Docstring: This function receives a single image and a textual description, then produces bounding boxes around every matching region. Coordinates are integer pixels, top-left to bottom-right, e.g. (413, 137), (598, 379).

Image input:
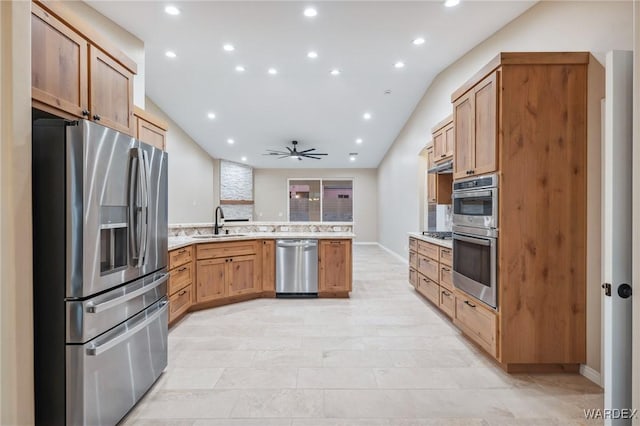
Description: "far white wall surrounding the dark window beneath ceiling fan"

(253, 169), (378, 242)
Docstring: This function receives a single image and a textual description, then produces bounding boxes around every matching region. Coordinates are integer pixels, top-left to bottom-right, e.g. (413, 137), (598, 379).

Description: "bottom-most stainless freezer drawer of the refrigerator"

(66, 297), (169, 426)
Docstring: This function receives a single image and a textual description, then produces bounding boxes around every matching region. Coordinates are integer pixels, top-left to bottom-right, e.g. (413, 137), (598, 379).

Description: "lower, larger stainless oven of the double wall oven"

(452, 225), (498, 308)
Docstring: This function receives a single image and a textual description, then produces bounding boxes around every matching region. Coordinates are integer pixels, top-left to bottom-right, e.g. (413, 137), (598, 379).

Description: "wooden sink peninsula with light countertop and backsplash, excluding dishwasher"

(167, 222), (355, 325)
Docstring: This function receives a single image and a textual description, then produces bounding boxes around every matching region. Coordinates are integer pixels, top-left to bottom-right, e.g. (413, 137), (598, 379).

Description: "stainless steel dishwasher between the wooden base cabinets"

(276, 240), (318, 297)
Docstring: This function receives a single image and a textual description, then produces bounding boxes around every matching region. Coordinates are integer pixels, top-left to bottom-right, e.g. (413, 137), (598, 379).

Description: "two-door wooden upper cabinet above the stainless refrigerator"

(31, 2), (136, 136)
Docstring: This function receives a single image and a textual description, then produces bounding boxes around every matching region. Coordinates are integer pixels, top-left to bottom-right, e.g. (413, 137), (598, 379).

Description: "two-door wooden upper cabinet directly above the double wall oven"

(453, 70), (500, 179)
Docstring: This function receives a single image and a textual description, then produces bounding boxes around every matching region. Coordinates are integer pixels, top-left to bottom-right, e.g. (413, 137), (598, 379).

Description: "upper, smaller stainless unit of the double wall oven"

(452, 174), (498, 229)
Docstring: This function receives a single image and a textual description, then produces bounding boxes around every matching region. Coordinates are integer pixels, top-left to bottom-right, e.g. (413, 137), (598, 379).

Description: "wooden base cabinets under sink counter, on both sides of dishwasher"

(167, 239), (352, 325)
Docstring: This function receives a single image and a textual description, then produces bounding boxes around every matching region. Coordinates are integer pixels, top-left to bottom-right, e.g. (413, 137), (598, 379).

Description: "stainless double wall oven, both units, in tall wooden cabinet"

(452, 174), (498, 308)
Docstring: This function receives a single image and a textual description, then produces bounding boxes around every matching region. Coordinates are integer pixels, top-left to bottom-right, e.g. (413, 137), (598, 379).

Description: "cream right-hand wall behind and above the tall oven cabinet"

(378, 2), (633, 380)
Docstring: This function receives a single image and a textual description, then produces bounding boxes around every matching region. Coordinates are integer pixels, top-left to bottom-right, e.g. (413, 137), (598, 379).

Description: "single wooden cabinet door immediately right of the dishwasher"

(319, 240), (351, 291)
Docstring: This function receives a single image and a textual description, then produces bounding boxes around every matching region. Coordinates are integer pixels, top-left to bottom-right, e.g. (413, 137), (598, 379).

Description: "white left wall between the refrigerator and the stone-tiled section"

(145, 98), (220, 223)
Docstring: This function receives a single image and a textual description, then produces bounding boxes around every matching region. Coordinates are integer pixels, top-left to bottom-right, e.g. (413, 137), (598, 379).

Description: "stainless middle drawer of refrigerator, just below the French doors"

(66, 270), (169, 343)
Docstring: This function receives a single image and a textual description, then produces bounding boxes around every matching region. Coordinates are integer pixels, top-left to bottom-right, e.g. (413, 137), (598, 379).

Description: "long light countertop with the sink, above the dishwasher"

(169, 232), (356, 250)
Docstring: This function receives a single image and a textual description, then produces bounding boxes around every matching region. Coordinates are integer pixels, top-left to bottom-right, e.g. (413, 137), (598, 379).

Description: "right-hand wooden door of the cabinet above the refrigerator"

(89, 46), (136, 137)
